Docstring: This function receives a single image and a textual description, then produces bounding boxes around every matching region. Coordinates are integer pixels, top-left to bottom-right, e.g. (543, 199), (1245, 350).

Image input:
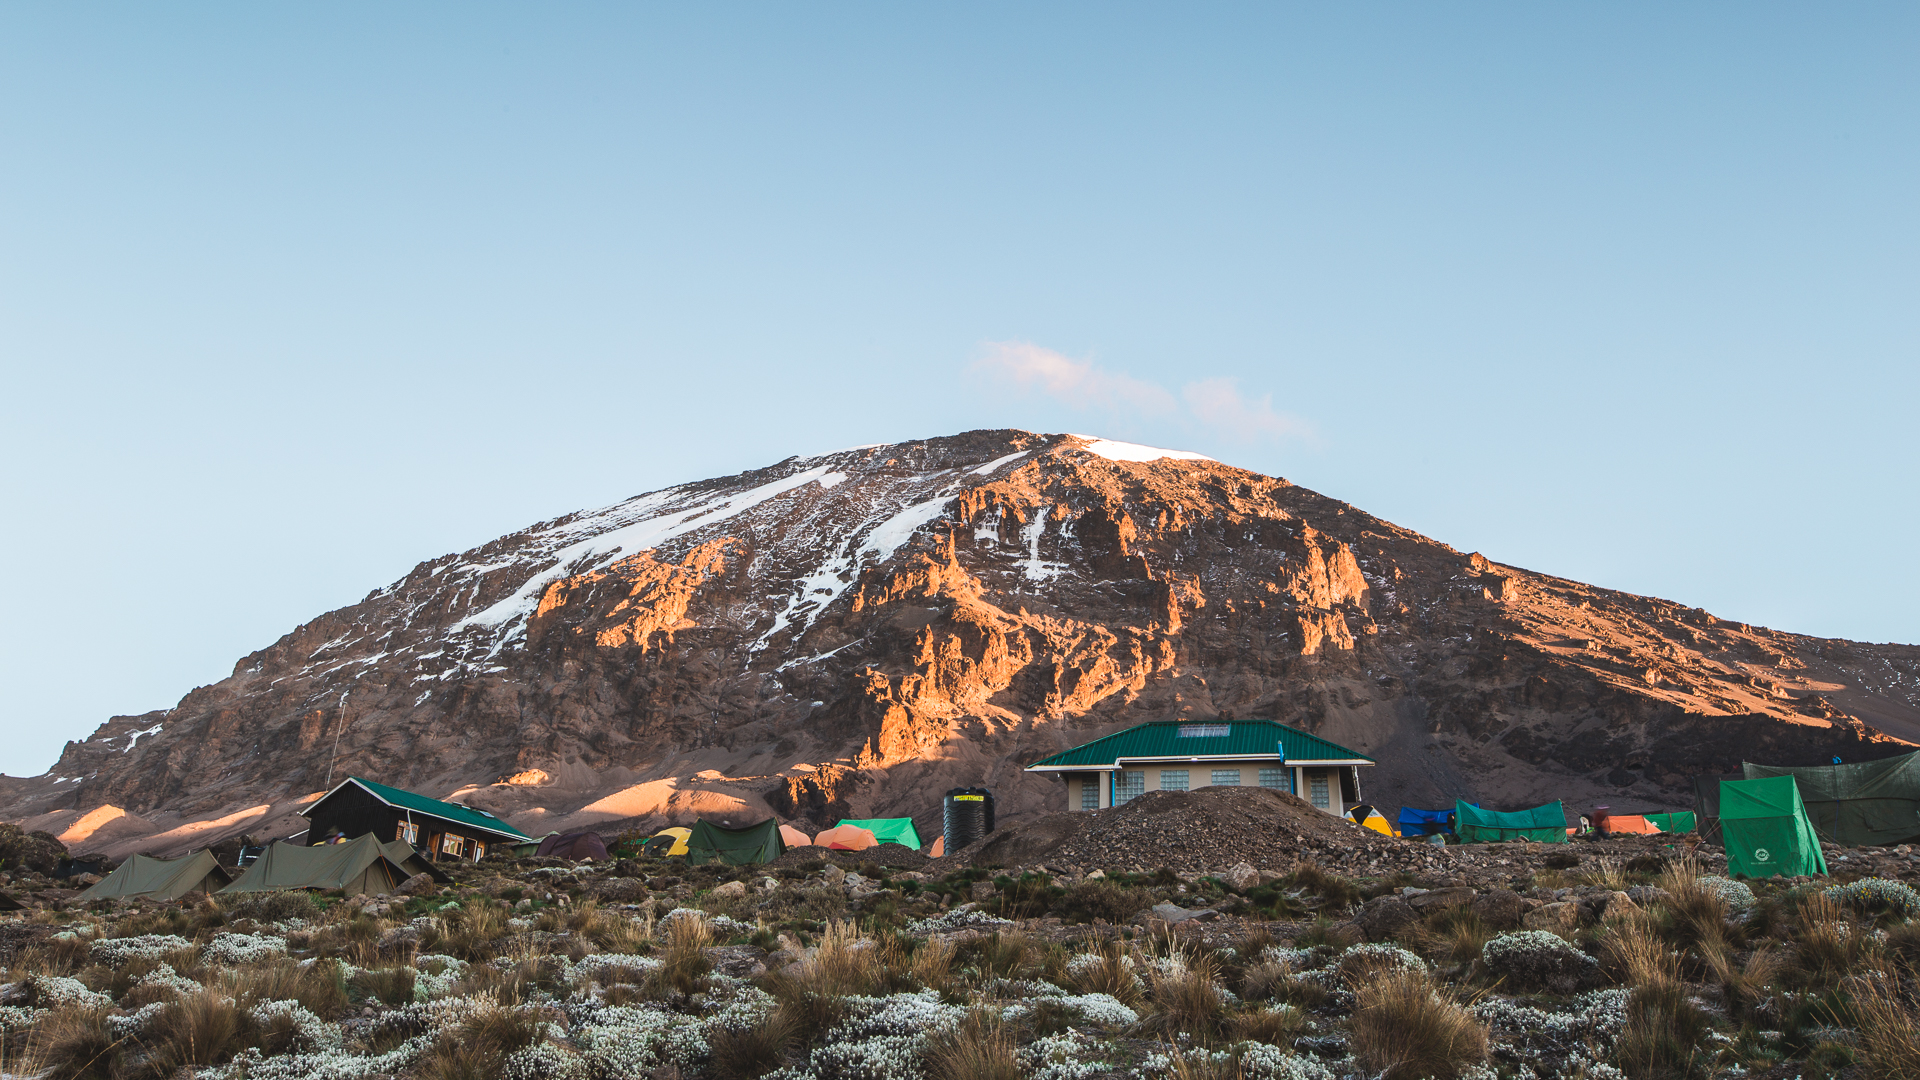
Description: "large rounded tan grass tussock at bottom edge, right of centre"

(1350, 969), (1488, 1080)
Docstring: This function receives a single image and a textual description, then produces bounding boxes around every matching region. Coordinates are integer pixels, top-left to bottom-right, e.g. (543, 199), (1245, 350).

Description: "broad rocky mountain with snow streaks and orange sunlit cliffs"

(0, 430), (1920, 851)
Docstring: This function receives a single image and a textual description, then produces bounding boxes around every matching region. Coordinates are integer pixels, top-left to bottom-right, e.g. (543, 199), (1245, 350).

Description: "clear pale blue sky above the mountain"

(0, 4), (1920, 774)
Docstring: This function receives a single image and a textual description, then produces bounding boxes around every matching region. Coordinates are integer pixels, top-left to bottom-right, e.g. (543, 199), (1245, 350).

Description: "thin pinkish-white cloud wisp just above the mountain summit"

(973, 342), (1313, 442)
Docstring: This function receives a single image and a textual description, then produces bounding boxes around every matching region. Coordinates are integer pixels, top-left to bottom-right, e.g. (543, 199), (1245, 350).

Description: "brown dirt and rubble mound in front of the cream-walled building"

(954, 788), (1428, 872)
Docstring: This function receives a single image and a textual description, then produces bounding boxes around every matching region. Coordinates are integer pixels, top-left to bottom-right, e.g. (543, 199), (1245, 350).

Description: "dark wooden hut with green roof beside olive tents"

(300, 776), (532, 861)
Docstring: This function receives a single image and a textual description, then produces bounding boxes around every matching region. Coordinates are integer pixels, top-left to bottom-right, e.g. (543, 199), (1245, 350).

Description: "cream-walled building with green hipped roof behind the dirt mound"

(1027, 721), (1373, 817)
